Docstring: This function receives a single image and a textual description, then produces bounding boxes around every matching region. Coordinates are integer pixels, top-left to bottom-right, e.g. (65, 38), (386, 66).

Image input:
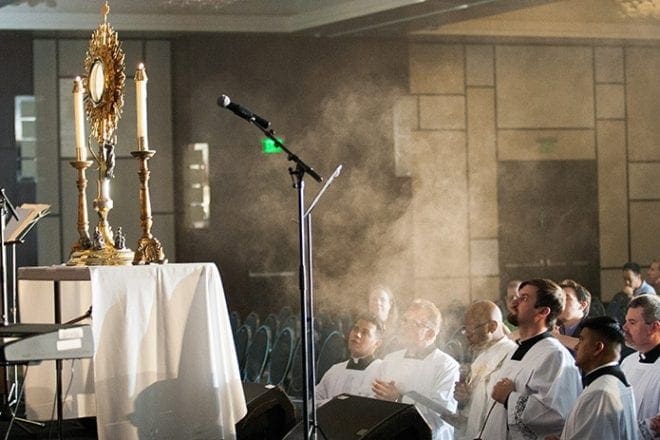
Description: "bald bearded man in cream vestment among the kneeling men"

(454, 301), (517, 440)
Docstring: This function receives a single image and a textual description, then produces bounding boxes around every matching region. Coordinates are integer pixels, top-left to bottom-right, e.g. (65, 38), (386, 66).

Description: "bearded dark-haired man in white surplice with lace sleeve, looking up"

(483, 279), (582, 440)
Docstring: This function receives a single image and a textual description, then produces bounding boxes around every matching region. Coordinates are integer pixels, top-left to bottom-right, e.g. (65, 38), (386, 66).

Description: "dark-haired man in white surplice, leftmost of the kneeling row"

(316, 315), (383, 405)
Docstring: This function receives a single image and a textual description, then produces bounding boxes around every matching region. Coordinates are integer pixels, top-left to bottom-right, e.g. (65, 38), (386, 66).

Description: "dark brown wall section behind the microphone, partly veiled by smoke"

(173, 36), (410, 314)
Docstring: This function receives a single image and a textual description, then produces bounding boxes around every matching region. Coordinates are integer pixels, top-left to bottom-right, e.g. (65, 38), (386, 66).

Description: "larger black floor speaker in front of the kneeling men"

(285, 394), (431, 440)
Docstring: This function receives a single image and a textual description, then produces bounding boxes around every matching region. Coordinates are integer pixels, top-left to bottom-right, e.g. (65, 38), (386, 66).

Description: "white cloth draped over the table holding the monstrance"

(19, 263), (247, 439)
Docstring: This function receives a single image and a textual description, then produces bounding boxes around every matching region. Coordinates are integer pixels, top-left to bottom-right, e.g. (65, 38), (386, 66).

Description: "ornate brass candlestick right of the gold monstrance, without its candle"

(131, 150), (167, 264)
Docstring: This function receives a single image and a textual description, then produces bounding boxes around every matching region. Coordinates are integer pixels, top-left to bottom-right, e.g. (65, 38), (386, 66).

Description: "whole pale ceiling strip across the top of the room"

(0, 0), (660, 39)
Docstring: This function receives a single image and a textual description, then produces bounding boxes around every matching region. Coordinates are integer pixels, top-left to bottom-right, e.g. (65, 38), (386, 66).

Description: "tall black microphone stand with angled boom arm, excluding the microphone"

(248, 121), (327, 439)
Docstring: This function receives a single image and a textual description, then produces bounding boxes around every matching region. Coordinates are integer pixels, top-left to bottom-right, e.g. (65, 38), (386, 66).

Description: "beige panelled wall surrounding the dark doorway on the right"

(395, 42), (660, 306)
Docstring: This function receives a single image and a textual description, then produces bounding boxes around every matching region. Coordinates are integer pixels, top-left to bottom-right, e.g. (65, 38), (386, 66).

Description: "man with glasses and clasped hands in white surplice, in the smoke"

(372, 299), (459, 440)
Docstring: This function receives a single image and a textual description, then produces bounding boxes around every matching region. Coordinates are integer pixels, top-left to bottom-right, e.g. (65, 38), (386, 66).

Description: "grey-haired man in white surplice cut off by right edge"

(621, 295), (660, 438)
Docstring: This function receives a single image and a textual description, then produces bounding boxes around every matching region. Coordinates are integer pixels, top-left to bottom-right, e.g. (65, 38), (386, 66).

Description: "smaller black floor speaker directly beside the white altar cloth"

(236, 383), (296, 440)
